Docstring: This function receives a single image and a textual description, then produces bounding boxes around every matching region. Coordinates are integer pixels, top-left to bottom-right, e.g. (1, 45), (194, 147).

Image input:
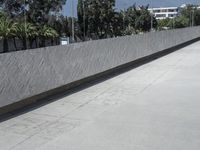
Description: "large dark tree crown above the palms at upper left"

(0, 0), (66, 30)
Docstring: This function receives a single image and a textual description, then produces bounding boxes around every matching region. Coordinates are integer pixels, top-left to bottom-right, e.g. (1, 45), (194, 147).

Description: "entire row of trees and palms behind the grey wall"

(0, 0), (200, 52)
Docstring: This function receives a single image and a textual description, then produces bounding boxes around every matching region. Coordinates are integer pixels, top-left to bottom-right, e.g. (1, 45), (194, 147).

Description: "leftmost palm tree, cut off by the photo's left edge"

(0, 17), (16, 52)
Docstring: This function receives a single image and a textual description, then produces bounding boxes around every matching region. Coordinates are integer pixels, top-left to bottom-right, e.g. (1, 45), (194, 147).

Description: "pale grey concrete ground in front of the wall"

(0, 42), (200, 150)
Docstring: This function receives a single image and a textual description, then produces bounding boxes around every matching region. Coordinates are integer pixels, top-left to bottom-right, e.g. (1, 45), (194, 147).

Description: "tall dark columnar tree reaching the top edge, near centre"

(82, 0), (115, 38)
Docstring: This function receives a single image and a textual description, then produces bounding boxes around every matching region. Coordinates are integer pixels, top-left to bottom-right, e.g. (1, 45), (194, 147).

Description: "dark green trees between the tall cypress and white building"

(77, 0), (157, 39)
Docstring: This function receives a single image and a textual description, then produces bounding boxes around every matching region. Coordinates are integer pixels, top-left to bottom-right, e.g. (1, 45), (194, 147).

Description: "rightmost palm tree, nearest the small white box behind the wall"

(39, 25), (59, 47)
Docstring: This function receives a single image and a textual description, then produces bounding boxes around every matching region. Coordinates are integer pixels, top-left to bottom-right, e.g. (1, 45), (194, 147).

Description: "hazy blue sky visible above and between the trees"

(63, 0), (200, 16)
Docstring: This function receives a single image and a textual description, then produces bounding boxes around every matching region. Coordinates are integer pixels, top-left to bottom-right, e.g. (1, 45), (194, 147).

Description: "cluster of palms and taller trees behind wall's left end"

(0, 0), (68, 52)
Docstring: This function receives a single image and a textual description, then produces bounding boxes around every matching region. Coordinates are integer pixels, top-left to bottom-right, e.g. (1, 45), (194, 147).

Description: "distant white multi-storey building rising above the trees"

(149, 7), (179, 20)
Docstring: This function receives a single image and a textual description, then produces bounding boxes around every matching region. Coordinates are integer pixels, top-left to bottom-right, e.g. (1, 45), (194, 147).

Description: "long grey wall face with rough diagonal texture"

(0, 27), (200, 107)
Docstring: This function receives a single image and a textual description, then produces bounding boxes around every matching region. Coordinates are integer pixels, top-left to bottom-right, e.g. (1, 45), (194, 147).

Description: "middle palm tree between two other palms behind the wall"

(16, 23), (38, 50)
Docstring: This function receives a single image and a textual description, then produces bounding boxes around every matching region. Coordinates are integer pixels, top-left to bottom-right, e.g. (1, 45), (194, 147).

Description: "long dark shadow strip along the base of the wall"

(0, 38), (200, 123)
